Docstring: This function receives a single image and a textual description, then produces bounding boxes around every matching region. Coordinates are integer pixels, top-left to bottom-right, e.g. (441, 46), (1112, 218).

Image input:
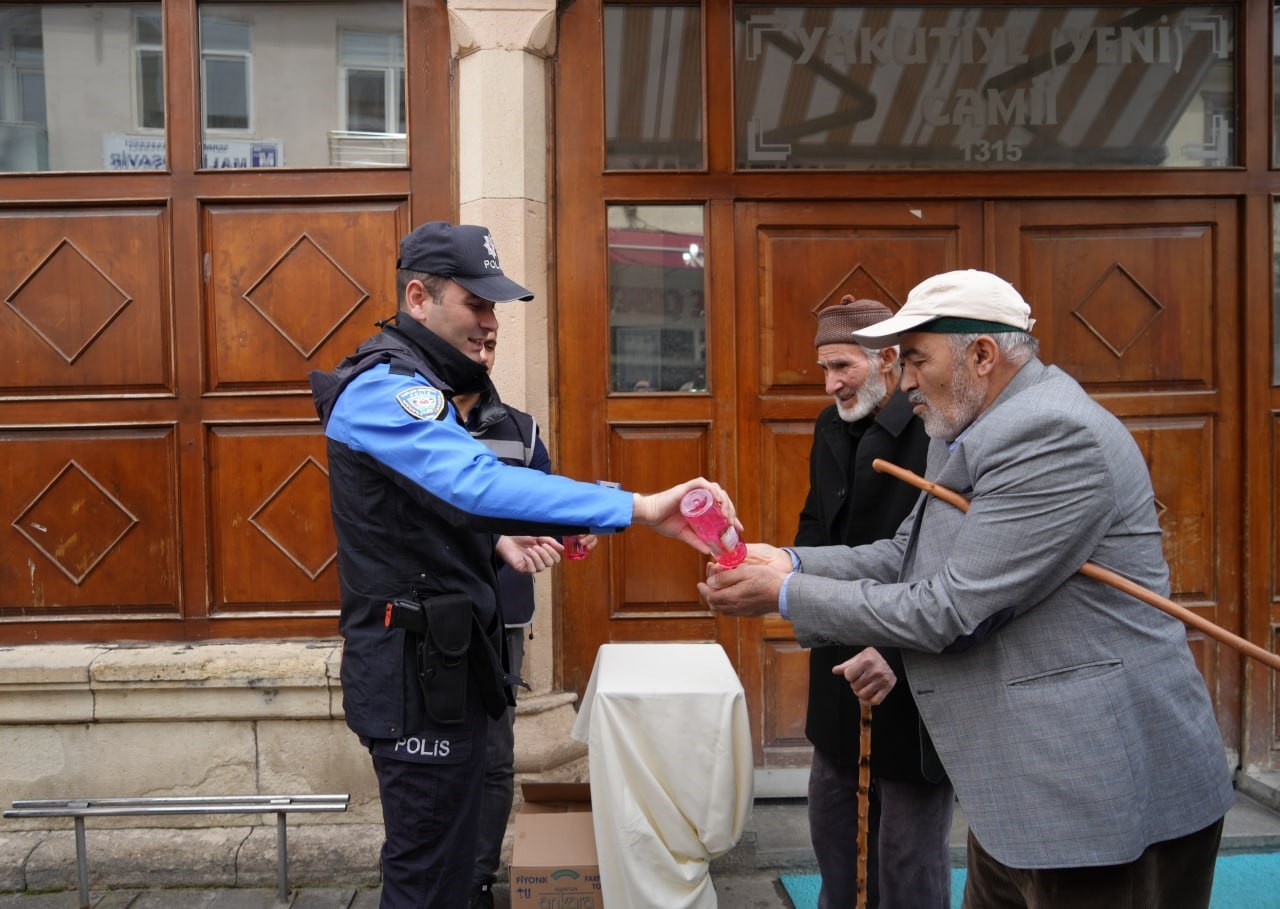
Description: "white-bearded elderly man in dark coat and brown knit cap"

(795, 297), (955, 909)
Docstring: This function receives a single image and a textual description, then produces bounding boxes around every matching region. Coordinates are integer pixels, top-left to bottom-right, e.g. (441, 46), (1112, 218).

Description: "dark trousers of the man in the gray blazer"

(964, 819), (1222, 909)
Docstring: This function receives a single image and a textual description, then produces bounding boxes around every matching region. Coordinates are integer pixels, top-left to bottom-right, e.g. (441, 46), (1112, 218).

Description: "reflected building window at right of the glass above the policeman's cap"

(338, 29), (404, 134)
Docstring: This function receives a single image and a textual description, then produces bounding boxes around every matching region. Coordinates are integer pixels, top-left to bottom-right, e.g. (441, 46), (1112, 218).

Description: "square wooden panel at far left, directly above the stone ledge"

(0, 426), (182, 621)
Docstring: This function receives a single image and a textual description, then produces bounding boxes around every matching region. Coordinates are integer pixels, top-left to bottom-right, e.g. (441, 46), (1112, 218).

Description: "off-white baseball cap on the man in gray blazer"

(852, 269), (1036, 347)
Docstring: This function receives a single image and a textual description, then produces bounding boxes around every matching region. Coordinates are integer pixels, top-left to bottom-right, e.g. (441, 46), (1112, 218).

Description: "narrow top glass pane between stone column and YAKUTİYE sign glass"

(604, 4), (703, 170)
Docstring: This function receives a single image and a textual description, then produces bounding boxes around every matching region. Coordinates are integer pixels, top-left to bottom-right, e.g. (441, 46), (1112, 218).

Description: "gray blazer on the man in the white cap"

(786, 360), (1234, 868)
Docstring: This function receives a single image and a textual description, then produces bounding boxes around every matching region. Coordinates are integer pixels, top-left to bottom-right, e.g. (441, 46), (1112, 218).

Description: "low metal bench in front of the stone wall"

(4, 794), (351, 909)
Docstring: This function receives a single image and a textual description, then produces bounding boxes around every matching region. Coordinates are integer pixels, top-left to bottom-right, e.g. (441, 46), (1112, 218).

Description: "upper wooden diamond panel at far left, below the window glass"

(0, 206), (173, 397)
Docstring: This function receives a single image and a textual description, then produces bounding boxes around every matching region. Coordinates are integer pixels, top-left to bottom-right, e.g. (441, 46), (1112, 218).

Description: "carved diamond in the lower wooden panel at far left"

(13, 461), (138, 586)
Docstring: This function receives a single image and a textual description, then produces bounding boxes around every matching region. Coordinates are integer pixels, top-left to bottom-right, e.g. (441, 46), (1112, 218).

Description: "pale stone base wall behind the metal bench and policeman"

(0, 640), (586, 891)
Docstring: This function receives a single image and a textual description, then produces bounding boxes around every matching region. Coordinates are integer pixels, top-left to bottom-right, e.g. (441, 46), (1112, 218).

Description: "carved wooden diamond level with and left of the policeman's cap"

(244, 233), (369, 358)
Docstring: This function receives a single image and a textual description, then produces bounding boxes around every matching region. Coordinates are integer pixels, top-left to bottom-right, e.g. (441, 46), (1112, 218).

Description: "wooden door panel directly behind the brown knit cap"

(756, 217), (959, 393)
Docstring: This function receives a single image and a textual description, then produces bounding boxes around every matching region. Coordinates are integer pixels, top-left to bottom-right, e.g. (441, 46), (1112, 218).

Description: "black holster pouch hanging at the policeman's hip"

(417, 594), (472, 723)
